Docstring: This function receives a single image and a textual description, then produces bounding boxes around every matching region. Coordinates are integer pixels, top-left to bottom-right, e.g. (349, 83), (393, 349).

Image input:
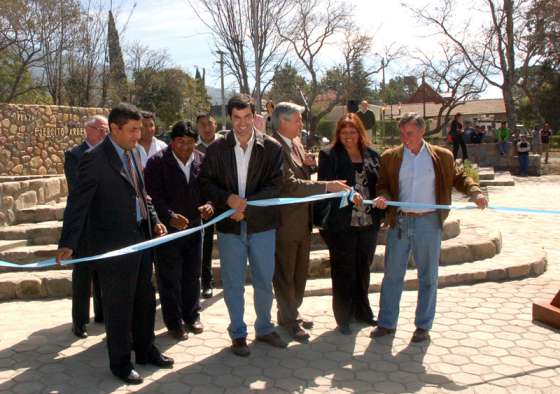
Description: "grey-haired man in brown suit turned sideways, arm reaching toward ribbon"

(272, 103), (350, 342)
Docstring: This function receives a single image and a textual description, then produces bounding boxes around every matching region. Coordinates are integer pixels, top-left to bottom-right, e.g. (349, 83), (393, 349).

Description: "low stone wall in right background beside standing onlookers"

(468, 142), (541, 176)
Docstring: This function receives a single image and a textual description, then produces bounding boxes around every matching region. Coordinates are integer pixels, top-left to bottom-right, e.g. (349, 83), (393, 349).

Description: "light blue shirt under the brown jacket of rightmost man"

(399, 143), (436, 212)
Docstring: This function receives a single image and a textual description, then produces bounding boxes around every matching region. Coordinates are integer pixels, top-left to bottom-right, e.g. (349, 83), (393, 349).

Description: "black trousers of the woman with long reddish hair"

(321, 227), (377, 326)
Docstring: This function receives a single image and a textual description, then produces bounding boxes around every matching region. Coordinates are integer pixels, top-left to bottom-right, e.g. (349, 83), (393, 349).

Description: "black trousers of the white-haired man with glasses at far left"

(72, 263), (103, 326)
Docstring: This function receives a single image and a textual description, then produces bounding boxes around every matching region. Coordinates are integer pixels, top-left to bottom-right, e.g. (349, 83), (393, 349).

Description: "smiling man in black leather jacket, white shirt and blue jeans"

(199, 95), (287, 357)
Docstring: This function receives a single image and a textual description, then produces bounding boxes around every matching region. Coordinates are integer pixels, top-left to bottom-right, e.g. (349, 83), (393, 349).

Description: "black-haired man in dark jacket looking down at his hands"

(144, 121), (213, 341)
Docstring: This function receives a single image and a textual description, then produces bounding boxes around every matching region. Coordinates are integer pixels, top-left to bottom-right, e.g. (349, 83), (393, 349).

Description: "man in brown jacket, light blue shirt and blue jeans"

(371, 113), (488, 342)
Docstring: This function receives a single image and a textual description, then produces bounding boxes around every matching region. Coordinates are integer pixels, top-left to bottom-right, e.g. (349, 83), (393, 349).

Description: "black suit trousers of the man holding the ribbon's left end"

(95, 243), (158, 376)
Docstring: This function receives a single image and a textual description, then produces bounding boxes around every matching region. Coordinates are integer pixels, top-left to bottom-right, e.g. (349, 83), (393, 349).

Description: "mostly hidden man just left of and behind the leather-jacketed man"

(196, 113), (223, 298)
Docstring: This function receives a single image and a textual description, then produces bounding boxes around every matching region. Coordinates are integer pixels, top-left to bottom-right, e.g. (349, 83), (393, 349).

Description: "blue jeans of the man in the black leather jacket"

(218, 222), (276, 339)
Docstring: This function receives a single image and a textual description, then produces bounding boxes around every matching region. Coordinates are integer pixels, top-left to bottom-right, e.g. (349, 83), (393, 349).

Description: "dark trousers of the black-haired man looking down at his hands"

(156, 233), (202, 330)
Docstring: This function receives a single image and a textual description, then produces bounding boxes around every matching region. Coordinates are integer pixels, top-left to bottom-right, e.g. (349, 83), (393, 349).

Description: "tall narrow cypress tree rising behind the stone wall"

(107, 11), (128, 104)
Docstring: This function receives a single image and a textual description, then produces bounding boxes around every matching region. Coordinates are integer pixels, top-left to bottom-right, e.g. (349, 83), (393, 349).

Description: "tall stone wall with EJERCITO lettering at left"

(0, 104), (109, 175)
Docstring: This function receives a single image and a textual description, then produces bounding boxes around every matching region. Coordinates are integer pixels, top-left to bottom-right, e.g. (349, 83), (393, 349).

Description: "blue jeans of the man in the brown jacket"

(378, 213), (441, 330)
